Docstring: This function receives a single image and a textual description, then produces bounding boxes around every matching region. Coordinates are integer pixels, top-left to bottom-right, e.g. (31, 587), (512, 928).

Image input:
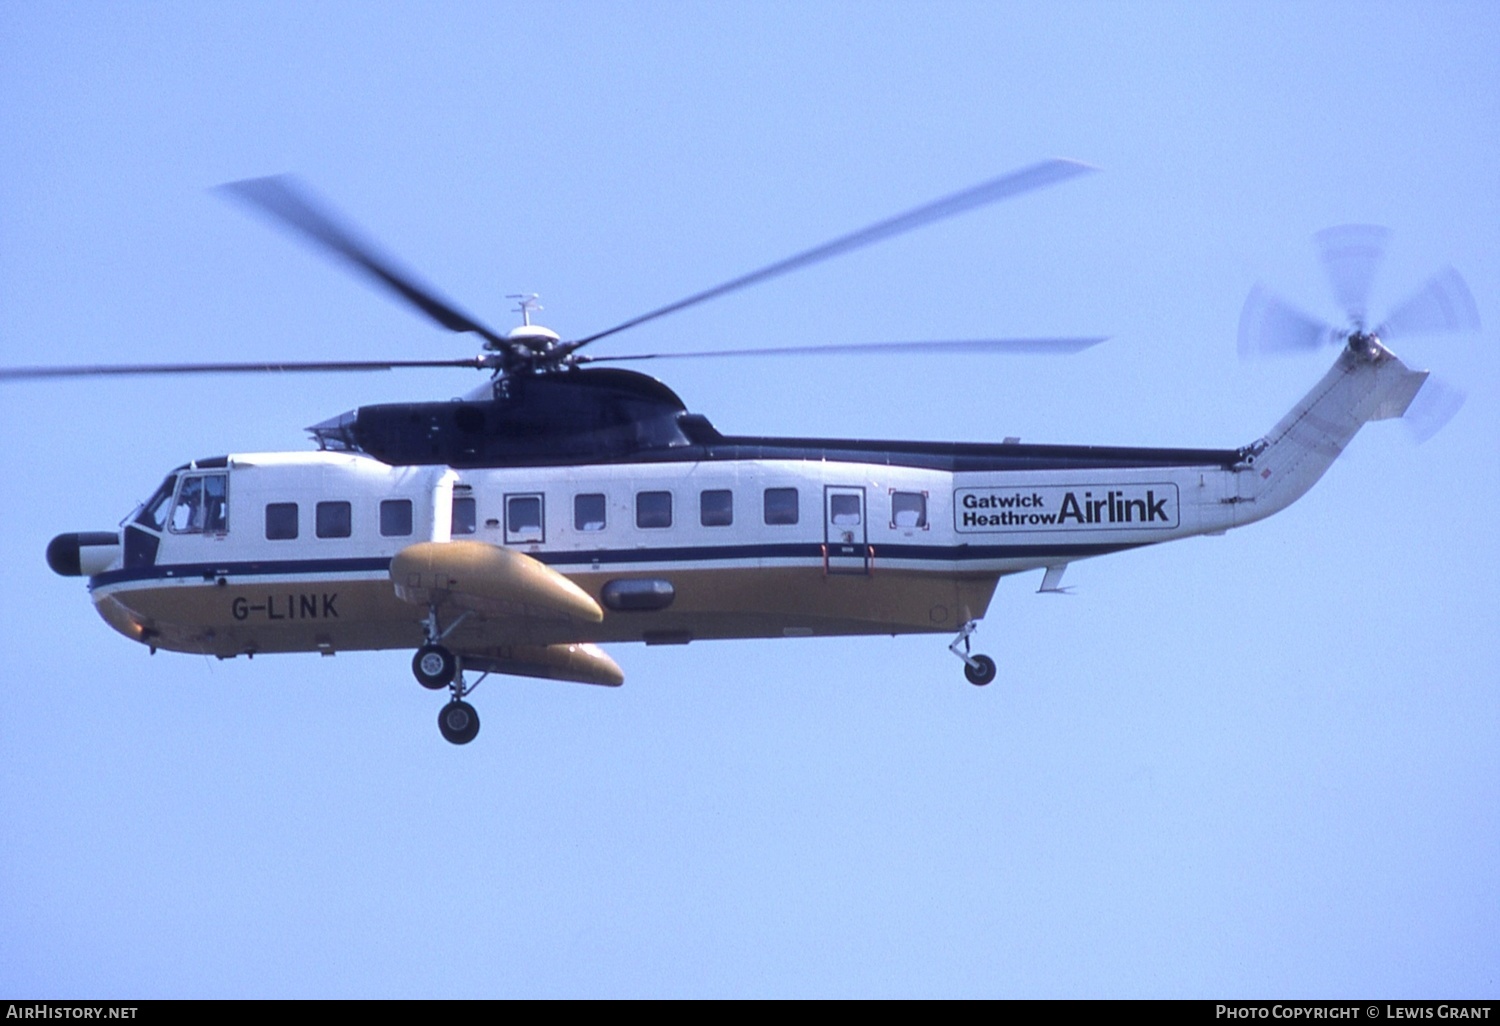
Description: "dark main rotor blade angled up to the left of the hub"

(218, 174), (504, 345)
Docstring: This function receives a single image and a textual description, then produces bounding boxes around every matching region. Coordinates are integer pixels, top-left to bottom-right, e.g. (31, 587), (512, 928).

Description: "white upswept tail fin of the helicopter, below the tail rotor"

(1235, 336), (1427, 525)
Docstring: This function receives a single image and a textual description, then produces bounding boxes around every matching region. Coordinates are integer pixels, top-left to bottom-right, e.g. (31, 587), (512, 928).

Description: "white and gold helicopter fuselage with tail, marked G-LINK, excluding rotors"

(64, 344), (1425, 702)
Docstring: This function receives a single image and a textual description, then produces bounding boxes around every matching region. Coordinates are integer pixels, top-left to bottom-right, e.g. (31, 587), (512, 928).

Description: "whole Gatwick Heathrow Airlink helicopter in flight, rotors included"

(0, 161), (1478, 744)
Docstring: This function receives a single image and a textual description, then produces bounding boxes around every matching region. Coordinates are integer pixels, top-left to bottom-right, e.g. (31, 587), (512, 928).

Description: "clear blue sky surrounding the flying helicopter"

(0, 3), (1500, 998)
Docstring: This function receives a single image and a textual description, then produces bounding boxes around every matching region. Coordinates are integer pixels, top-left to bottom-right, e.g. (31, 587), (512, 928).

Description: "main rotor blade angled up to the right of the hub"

(567, 161), (1095, 351)
